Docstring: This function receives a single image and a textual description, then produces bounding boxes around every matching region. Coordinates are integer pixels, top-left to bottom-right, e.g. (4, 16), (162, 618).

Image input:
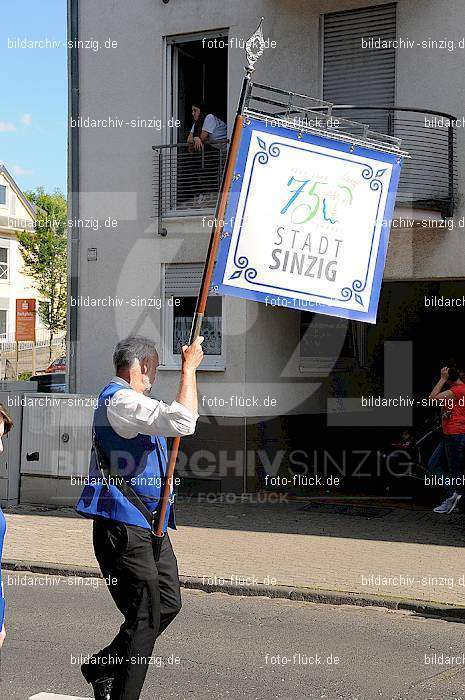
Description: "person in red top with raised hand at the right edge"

(428, 367), (465, 513)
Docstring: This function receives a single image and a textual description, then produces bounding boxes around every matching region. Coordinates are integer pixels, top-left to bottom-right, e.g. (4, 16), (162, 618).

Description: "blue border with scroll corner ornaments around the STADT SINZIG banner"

(213, 119), (401, 323)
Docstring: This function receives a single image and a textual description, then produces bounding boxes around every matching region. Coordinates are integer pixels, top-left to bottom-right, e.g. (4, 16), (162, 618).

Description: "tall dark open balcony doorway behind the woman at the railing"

(163, 30), (228, 212)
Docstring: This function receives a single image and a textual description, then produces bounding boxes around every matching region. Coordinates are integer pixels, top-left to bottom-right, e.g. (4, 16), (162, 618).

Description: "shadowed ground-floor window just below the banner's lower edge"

(300, 311), (367, 377)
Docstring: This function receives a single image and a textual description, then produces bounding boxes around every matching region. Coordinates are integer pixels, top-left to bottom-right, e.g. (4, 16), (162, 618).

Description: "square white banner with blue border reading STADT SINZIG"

(213, 118), (401, 323)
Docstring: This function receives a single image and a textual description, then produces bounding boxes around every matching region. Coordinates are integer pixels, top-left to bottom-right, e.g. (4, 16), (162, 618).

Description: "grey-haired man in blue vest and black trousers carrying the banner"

(76, 336), (203, 700)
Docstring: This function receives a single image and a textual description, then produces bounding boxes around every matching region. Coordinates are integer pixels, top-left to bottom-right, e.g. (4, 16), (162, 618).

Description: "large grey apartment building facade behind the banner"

(69, 0), (465, 493)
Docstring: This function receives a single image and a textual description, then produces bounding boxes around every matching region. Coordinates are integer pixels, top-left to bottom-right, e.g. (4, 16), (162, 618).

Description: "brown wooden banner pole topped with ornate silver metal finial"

(154, 17), (265, 540)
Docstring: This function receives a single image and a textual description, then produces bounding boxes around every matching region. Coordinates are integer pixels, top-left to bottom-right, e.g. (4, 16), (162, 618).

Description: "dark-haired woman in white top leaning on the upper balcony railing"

(187, 100), (227, 206)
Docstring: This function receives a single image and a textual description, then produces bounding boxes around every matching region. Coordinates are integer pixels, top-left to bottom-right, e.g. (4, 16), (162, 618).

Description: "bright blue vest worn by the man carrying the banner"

(76, 382), (176, 531)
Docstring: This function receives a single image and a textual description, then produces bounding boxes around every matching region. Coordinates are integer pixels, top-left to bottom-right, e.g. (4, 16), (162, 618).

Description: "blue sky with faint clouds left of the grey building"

(0, 0), (68, 193)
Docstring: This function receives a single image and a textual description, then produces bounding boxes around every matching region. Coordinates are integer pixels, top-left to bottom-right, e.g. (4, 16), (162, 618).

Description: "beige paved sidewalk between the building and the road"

(3, 499), (465, 615)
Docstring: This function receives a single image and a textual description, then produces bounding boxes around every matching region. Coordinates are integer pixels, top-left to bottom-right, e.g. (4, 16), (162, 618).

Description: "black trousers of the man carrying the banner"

(82, 519), (181, 700)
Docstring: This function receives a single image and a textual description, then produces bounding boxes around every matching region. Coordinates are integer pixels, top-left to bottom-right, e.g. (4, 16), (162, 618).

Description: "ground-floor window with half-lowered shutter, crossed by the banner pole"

(163, 263), (225, 369)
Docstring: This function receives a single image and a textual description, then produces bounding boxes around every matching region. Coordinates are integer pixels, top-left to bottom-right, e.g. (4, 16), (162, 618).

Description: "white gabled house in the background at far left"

(0, 164), (44, 340)
